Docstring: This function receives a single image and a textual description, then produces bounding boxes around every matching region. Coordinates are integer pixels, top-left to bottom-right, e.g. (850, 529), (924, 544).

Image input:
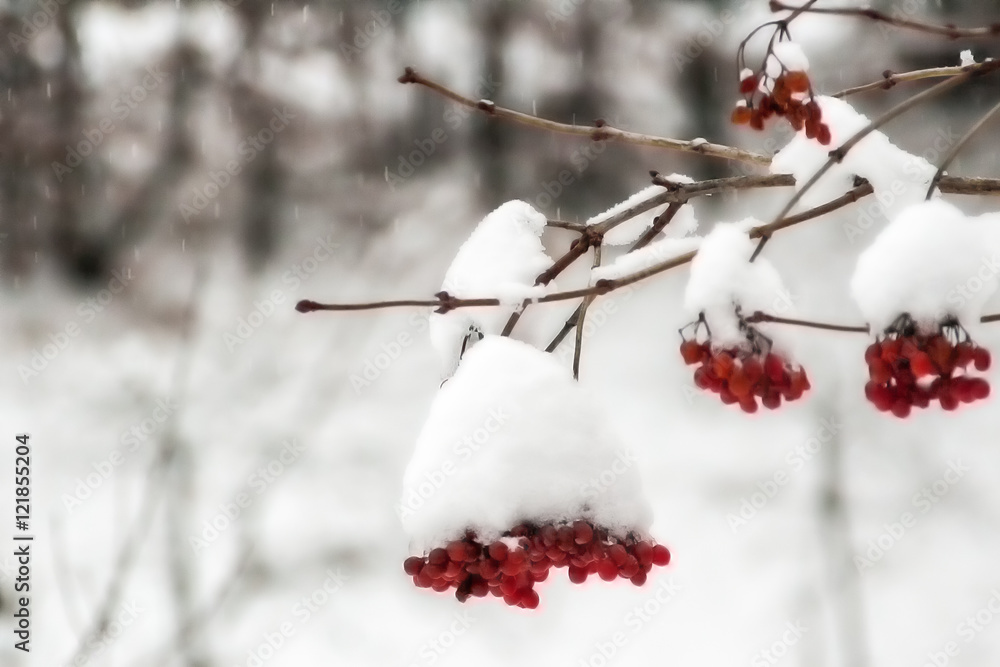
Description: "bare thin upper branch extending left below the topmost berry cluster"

(398, 67), (770, 165)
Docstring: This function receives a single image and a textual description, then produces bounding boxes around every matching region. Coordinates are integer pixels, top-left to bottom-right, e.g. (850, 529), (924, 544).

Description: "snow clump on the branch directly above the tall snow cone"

(430, 200), (555, 374)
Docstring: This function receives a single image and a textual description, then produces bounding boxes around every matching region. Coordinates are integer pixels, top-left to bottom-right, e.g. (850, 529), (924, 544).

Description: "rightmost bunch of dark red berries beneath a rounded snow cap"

(865, 315), (992, 418)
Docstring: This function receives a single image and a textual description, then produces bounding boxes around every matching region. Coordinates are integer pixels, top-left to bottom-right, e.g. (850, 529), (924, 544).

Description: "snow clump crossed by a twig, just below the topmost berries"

(771, 96), (937, 218)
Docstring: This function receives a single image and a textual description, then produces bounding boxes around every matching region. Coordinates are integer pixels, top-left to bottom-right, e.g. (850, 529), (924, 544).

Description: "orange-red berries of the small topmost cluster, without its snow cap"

(732, 70), (831, 146)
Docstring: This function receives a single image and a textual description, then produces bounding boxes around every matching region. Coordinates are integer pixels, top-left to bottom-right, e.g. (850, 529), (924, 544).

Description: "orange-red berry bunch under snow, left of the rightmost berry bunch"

(681, 340), (810, 413)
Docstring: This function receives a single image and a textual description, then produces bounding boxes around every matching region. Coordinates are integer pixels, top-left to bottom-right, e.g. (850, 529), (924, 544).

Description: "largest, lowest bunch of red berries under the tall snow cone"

(403, 521), (670, 609)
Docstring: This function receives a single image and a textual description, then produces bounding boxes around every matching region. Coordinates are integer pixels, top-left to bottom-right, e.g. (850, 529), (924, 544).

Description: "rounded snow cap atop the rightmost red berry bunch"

(851, 199), (1000, 333)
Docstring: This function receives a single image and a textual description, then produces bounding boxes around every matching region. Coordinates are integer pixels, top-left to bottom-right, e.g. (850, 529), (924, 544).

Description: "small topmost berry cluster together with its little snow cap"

(732, 42), (832, 146)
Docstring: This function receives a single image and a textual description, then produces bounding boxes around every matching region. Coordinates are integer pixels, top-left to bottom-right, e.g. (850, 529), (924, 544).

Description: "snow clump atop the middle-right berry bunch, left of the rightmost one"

(684, 219), (788, 349)
